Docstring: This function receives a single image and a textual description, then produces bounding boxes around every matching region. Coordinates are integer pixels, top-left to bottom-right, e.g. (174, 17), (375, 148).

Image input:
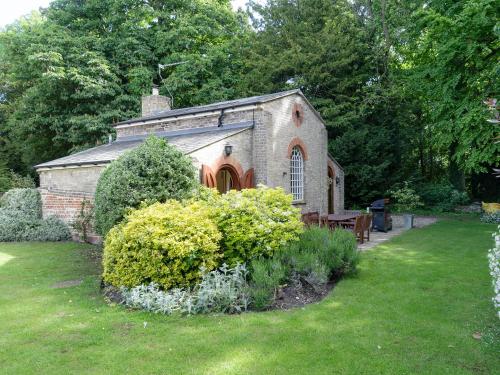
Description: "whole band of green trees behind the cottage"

(0, 0), (500, 205)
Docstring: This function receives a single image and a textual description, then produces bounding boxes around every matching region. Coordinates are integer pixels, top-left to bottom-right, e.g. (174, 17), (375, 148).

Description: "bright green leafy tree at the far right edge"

(403, 0), (500, 189)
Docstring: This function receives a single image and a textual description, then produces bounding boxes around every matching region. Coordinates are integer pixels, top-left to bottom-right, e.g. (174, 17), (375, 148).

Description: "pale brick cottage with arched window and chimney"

(35, 88), (344, 238)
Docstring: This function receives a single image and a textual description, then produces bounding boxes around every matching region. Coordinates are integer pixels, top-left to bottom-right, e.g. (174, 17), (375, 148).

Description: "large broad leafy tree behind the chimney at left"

(0, 0), (250, 167)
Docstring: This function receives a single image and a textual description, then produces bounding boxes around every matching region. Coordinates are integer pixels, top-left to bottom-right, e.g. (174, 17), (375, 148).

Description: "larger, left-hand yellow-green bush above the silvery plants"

(103, 200), (221, 289)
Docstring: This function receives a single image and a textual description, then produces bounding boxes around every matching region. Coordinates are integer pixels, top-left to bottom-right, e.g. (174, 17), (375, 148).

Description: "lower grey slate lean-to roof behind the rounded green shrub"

(35, 122), (253, 169)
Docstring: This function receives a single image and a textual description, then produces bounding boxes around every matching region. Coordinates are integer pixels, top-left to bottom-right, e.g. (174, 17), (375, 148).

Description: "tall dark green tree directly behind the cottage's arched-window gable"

(246, 0), (416, 204)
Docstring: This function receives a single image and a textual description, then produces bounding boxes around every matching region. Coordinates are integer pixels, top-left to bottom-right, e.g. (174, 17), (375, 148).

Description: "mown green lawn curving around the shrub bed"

(0, 219), (500, 375)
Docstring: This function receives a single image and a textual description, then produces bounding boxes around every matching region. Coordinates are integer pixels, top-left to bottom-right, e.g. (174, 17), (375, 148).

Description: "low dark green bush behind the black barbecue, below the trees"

(418, 182), (469, 212)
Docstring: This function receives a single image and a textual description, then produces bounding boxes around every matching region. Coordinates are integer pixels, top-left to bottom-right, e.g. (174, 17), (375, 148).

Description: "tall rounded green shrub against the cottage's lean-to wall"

(94, 136), (197, 236)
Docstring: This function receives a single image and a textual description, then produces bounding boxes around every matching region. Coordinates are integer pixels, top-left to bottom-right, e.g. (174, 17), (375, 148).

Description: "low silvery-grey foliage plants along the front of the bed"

(121, 264), (249, 314)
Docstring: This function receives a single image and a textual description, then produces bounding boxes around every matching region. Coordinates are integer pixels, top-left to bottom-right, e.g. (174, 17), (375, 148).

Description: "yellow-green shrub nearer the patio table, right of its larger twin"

(205, 186), (303, 266)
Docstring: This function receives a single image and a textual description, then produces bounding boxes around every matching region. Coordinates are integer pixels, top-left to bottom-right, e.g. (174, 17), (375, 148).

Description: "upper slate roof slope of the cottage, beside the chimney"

(114, 89), (303, 126)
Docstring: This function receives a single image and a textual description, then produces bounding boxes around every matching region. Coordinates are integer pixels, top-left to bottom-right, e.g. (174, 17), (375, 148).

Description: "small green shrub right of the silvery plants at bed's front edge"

(250, 256), (289, 310)
